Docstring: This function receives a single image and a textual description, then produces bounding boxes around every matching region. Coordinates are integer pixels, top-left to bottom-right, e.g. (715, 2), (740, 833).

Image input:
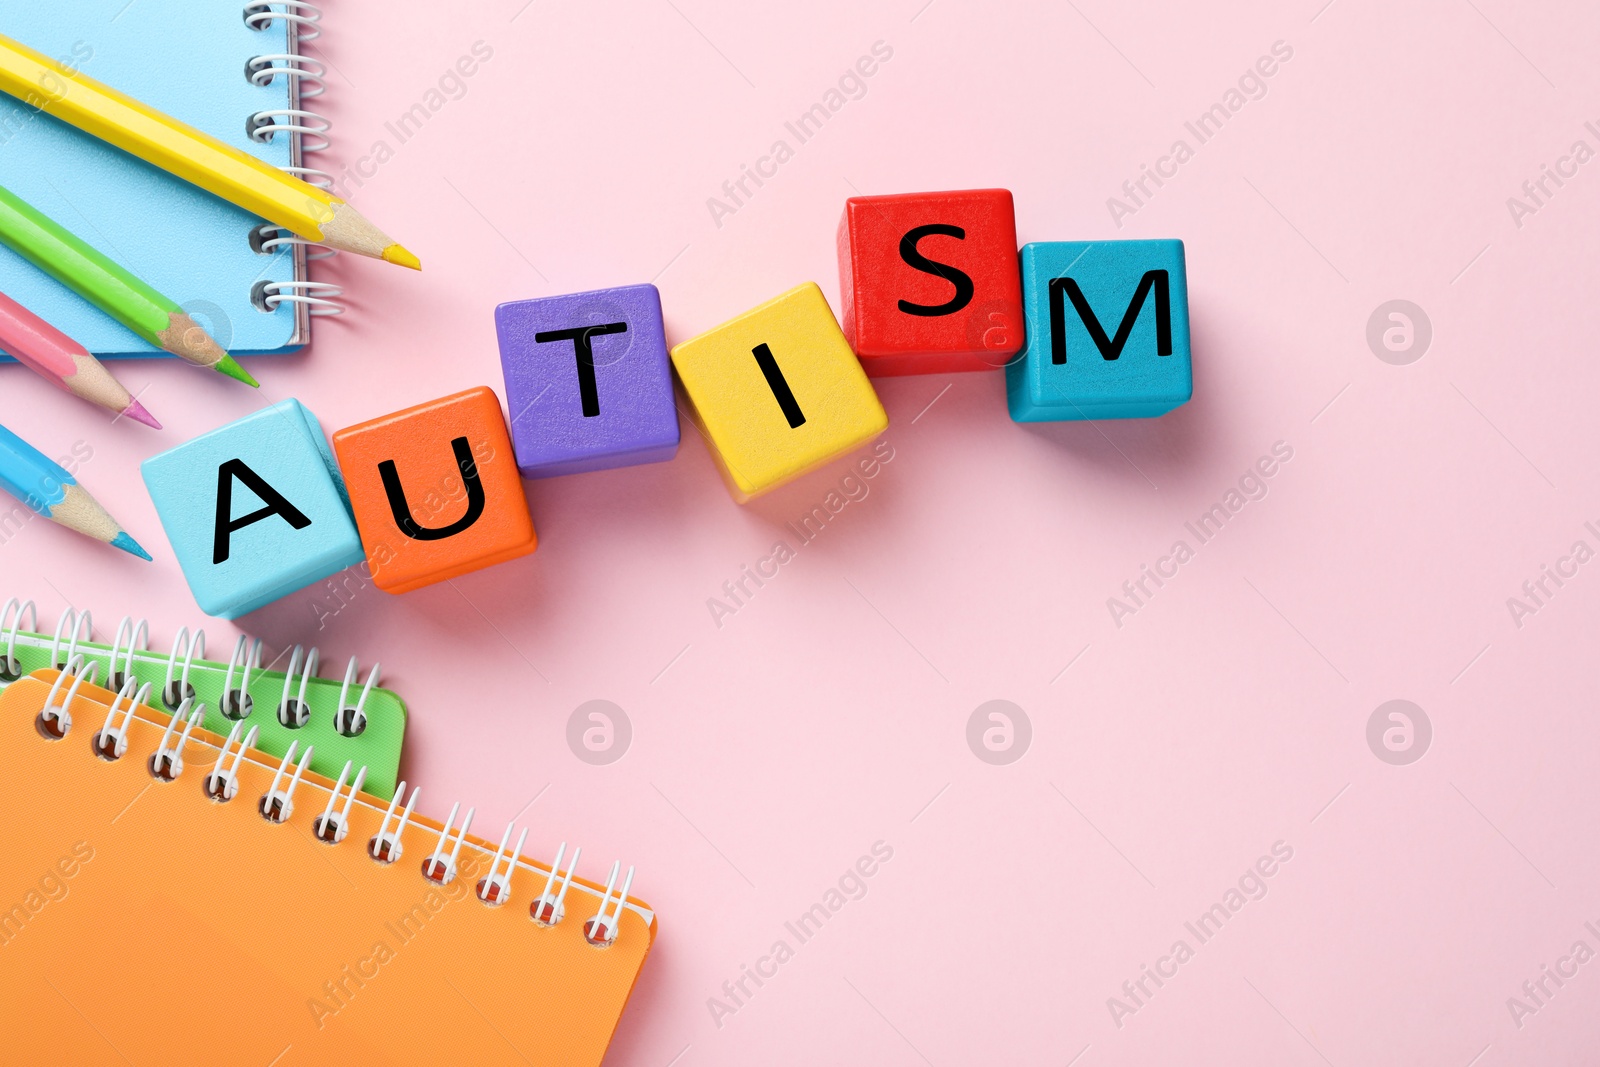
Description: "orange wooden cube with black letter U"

(333, 386), (539, 593)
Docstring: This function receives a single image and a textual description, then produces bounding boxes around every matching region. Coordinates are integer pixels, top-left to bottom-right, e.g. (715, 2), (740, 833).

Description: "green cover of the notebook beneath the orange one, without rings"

(0, 632), (406, 803)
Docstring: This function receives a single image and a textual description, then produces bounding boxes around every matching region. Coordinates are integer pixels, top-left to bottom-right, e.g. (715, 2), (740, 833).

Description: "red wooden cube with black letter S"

(838, 189), (1022, 378)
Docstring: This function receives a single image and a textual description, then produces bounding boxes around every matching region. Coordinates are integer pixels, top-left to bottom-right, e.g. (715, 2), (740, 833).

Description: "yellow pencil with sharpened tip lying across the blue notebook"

(0, 35), (422, 270)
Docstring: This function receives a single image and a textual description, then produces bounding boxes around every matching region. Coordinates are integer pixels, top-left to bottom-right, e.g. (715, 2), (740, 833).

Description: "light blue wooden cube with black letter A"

(139, 400), (366, 619)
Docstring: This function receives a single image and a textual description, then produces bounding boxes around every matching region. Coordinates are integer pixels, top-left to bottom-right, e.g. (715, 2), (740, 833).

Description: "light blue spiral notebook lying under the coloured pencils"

(0, 0), (338, 358)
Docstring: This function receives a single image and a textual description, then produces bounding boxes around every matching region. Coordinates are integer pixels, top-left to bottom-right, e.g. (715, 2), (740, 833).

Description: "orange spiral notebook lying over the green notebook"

(0, 670), (656, 1067)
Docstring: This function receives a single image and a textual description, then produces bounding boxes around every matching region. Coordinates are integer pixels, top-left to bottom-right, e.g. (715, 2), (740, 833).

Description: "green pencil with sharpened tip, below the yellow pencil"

(0, 186), (258, 386)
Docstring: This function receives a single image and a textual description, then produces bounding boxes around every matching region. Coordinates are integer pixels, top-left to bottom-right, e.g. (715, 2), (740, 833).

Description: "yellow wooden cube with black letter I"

(672, 282), (890, 504)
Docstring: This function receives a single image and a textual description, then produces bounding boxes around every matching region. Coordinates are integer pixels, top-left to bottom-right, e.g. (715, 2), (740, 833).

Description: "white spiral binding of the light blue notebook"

(245, 0), (344, 318)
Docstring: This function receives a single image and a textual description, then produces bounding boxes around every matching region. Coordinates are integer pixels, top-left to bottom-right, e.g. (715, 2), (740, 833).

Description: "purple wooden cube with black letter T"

(494, 285), (678, 478)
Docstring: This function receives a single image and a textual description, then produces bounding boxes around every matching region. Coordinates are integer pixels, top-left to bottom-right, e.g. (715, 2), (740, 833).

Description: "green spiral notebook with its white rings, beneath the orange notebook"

(0, 597), (406, 800)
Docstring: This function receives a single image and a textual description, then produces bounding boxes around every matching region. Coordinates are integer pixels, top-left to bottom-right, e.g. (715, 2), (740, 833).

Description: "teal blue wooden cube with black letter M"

(1005, 240), (1194, 422)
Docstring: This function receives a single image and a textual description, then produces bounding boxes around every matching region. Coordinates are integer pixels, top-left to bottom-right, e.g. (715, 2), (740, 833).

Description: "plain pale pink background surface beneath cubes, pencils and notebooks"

(0, 0), (1600, 1067)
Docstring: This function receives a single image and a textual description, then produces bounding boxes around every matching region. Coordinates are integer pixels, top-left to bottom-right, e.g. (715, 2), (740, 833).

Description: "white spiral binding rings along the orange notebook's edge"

(32, 659), (651, 949)
